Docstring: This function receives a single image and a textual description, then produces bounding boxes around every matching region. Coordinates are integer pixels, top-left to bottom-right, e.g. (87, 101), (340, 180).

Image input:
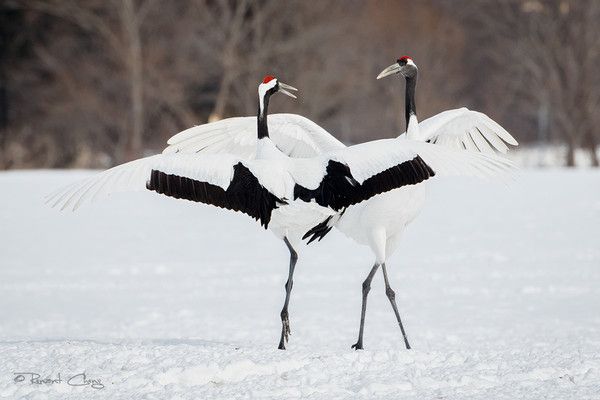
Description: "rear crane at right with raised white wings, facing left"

(164, 56), (517, 349)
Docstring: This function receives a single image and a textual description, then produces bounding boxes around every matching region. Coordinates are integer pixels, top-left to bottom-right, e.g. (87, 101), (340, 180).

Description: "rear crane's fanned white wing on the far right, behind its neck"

(419, 107), (518, 154)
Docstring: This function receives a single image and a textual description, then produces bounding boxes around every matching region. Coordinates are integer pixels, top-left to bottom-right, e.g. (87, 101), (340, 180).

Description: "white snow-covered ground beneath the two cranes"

(0, 170), (600, 399)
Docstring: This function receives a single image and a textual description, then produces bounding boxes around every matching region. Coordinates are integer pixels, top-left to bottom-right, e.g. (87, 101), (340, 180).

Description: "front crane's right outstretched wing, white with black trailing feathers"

(290, 138), (513, 211)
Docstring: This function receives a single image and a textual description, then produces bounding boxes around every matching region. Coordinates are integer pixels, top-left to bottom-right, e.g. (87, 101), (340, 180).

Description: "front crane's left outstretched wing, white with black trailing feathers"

(46, 154), (287, 227)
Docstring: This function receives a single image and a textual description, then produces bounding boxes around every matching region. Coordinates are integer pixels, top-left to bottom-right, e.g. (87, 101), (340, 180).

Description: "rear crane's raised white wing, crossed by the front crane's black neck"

(163, 114), (345, 159)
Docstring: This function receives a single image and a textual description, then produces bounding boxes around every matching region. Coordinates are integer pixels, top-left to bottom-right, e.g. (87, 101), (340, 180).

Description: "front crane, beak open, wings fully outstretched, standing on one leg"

(48, 72), (511, 349)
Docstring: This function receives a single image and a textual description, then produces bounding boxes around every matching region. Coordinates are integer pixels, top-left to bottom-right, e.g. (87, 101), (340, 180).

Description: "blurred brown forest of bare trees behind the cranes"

(0, 0), (600, 169)
